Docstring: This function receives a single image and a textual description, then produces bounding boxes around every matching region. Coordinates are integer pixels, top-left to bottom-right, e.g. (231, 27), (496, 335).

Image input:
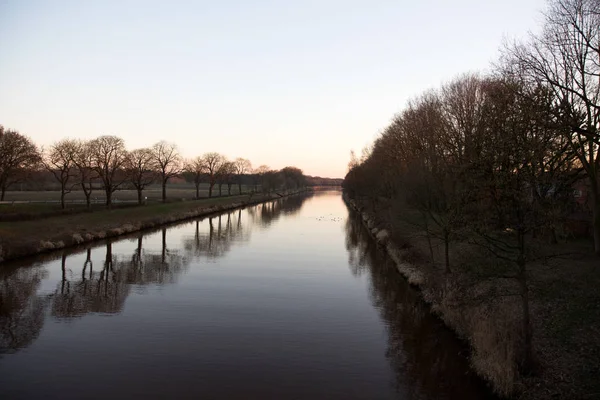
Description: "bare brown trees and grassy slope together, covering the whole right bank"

(342, 0), (600, 399)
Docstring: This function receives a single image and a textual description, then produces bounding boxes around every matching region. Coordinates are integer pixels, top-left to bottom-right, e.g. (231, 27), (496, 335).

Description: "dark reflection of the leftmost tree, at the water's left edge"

(0, 267), (46, 354)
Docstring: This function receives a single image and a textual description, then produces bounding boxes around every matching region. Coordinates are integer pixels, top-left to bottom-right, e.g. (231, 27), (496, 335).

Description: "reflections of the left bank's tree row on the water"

(0, 194), (311, 356)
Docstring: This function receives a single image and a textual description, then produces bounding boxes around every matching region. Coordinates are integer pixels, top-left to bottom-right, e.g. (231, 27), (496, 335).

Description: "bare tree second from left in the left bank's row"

(43, 139), (79, 210)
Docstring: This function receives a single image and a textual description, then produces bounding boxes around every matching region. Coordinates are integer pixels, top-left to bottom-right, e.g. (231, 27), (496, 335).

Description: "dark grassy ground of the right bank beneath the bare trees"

(344, 195), (600, 400)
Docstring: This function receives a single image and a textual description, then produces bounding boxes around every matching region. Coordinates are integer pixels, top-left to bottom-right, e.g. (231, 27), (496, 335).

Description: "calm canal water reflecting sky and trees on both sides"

(0, 192), (488, 400)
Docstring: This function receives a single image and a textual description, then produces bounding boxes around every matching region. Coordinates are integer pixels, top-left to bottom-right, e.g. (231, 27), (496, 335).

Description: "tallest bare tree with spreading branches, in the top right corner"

(505, 0), (600, 255)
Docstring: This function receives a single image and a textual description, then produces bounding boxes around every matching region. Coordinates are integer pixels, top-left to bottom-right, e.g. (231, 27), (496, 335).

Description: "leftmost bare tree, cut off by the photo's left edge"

(0, 125), (41, 201)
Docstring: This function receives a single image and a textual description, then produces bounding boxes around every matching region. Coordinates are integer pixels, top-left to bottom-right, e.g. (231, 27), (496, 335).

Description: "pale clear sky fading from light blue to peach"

(0, 0), (545, 178)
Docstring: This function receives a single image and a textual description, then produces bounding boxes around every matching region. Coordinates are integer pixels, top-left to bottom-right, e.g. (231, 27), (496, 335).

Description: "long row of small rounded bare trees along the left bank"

(0, 130), (307, 209)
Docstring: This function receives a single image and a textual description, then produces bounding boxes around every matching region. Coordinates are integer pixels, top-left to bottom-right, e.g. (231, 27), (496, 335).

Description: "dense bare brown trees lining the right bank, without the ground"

(344, 0), (600, 372)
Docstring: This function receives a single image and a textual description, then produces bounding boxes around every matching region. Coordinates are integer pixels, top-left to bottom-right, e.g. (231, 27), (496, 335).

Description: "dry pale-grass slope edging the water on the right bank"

(344, 194), (518, 397)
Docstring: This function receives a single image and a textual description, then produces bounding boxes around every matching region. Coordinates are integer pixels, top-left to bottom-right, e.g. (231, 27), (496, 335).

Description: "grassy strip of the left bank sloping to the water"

(0, 189), (308, 263)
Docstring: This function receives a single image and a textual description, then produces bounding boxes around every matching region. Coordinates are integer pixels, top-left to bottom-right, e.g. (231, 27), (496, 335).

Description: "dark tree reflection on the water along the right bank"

(345, 211), (495, 400)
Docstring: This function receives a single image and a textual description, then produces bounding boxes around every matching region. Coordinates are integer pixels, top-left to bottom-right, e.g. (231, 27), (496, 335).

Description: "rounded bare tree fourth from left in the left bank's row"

(89, 136), (127, 208)
